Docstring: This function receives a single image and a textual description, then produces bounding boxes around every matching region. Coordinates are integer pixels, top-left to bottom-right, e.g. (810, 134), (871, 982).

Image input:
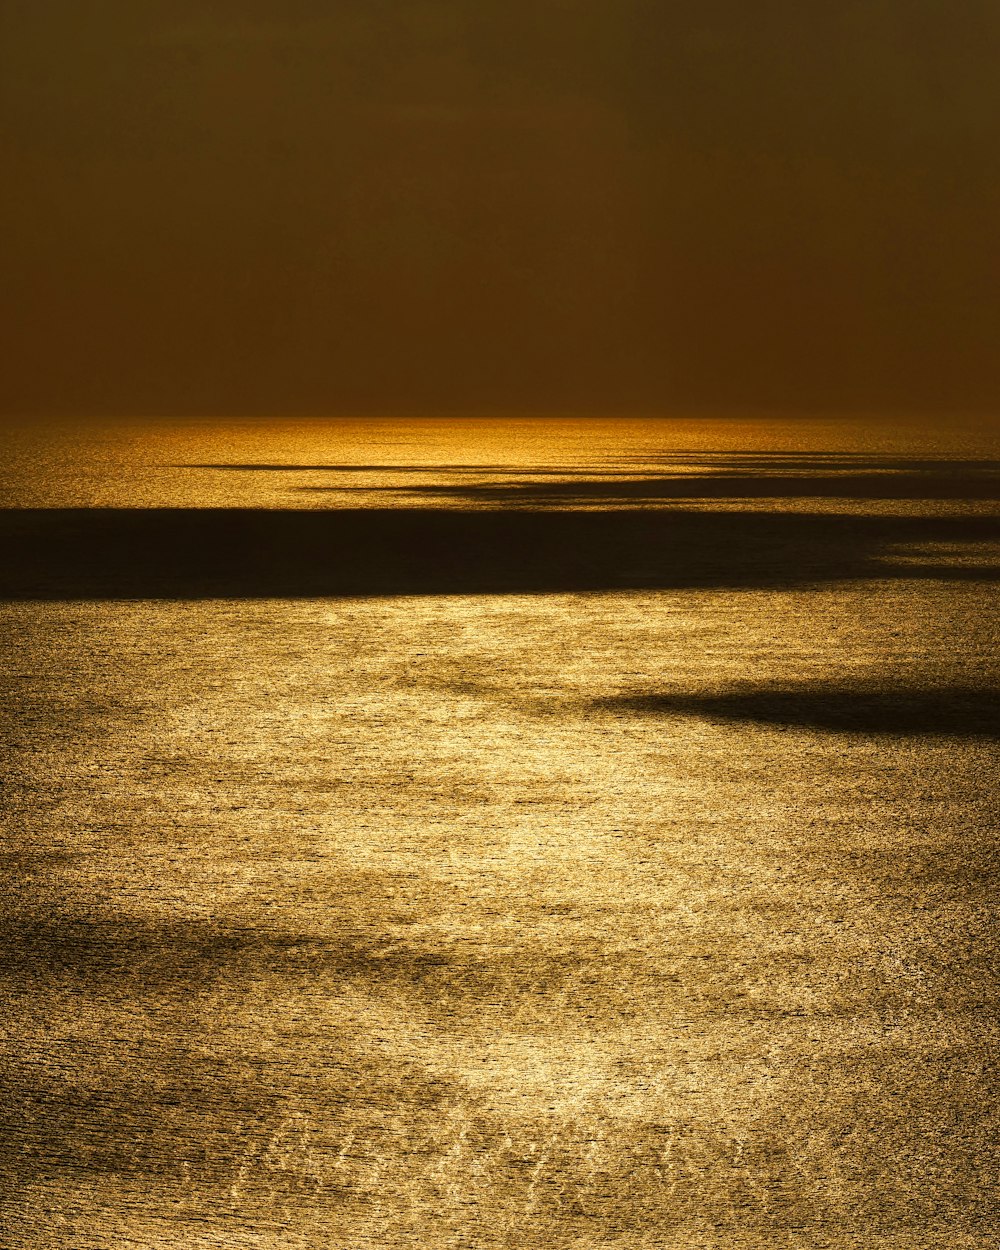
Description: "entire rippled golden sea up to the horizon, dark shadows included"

(0, 419), (1000, 1250)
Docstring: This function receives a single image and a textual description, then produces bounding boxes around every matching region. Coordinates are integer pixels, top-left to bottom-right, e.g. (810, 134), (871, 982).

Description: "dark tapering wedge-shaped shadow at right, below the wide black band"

(590, 685), (1000, 739)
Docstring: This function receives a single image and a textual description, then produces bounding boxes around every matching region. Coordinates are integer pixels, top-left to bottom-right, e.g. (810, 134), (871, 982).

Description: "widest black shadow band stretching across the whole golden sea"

(0, 508), (1000, 600)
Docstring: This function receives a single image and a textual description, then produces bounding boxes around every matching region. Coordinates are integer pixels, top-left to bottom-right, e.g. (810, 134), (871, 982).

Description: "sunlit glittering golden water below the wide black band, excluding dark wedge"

(0, 581), (1000, 1250)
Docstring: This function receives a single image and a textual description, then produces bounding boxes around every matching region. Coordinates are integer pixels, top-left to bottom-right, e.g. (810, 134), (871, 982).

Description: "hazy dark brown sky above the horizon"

(0, 0), (1000, 414)
